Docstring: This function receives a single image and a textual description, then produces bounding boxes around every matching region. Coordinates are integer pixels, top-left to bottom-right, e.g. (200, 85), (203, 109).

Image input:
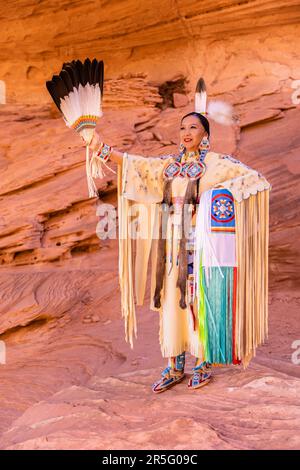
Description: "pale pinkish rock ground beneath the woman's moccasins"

(0, 255), (300, 449)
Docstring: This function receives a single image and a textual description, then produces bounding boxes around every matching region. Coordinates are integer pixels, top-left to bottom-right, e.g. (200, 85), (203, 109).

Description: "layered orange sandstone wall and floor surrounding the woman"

(0, 0), (300, 449)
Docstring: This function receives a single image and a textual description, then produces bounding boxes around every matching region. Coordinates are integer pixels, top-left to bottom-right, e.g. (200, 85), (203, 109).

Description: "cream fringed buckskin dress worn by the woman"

(118, 151), (271, 367)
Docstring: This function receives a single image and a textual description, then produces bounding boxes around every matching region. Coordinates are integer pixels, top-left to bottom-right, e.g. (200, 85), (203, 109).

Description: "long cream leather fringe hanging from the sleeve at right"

(235, 189), (269, 368)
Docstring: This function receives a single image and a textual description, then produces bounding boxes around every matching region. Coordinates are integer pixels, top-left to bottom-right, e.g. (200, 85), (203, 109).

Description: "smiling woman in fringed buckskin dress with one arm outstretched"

(89, 103), (271, 393)
